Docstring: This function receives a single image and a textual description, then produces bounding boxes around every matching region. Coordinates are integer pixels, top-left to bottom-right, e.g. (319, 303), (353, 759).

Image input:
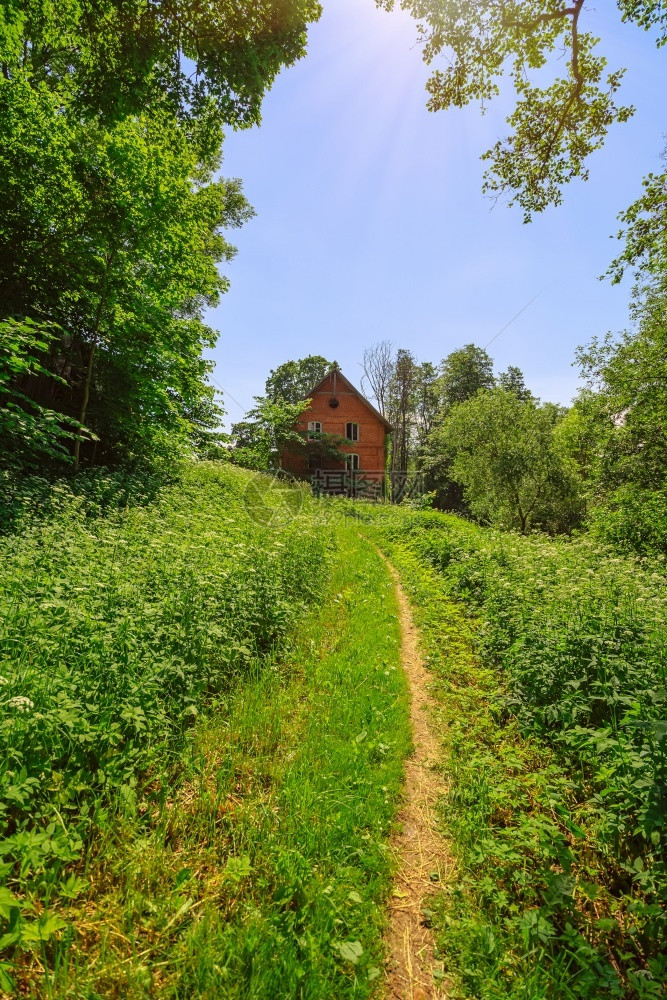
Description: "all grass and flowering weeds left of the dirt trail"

(0, 467), (410, 1000)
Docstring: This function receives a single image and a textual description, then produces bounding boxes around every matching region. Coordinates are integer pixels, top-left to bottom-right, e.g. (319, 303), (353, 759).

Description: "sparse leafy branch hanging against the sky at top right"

(376, 0), (667, 221)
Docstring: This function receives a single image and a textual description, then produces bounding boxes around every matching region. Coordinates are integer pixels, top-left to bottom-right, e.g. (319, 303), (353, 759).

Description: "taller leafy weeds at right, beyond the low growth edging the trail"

(357, 505), (667, 997)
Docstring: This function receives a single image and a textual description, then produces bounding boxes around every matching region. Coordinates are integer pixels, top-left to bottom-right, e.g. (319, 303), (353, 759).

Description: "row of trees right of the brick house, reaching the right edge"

(364, 320), (667, 551)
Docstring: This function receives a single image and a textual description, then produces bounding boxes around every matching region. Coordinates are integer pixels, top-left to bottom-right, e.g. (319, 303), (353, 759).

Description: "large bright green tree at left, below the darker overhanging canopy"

(0, 79), (250, 461)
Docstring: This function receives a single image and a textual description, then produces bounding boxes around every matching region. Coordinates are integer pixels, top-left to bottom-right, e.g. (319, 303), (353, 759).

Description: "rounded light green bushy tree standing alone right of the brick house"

(433, 388), (581, 533)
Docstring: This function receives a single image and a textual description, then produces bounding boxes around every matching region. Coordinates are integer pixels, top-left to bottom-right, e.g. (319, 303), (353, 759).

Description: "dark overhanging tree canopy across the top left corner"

(0, 0), (320, 129)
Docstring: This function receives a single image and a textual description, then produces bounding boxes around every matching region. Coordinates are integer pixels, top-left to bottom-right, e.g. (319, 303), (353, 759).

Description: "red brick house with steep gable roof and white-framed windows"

(281, 368), (392, 489)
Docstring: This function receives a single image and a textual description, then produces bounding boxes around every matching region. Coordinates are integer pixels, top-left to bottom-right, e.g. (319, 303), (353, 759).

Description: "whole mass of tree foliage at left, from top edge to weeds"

(0, 0), (319, 467)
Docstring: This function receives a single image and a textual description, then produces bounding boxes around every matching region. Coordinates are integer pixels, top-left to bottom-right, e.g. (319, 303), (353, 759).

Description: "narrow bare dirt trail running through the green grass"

(382, 556), (453, 1000)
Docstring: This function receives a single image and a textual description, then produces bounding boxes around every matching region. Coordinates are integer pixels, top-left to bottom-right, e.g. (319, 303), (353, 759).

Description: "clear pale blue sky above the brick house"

(208, 0), (667, 421)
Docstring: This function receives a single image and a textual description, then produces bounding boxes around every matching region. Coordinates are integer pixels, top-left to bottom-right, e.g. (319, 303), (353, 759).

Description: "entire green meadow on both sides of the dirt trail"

(0, 463), (667, 1000)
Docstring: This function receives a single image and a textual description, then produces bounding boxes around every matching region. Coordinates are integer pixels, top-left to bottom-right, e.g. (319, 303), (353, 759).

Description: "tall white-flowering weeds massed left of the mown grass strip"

(0, 464), (327, 968)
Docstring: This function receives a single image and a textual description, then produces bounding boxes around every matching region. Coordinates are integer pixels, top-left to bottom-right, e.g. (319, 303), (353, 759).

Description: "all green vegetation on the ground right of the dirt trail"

(355, 504), (667, 1000)
